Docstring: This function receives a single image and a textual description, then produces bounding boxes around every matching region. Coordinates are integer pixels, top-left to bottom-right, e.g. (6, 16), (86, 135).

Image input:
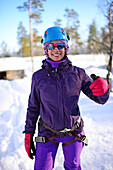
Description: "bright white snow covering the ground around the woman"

(0, 55), (113, 170)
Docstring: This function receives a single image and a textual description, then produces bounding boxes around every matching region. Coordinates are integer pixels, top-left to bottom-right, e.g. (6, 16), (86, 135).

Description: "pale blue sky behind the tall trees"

(0, 0), (106, 52)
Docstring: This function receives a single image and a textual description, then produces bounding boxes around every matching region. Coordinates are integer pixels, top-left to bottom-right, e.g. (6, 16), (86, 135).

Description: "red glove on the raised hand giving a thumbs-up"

(89, 77), (109, 96)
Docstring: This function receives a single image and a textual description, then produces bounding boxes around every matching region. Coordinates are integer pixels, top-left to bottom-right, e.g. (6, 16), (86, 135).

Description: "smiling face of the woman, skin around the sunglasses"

(48, 40), (65, 61)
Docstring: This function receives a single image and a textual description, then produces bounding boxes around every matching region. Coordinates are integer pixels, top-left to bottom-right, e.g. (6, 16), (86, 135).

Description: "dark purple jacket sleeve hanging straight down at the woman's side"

(23, 75), (40, 133)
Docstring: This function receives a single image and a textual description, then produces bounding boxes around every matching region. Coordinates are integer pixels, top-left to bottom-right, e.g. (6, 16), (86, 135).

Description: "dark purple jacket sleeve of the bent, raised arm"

(82, 70), (110, 104)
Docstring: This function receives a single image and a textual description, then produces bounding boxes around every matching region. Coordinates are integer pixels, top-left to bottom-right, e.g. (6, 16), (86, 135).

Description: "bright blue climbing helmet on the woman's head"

(41, 26), (69, 44)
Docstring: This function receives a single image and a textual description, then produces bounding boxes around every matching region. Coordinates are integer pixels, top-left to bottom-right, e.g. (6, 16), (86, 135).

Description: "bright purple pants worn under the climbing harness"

(34, 133), (83, 170)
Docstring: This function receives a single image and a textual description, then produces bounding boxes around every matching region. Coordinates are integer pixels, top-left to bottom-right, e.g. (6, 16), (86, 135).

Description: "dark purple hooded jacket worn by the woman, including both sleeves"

(24, 59), (109, 136)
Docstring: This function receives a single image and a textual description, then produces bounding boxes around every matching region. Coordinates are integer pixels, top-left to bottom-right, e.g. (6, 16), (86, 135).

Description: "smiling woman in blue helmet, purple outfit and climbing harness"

(24, 27), (109, 170)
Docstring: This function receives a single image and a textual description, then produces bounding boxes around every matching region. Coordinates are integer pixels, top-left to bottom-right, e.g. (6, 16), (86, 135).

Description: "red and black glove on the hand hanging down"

(25, 133), (36, 159)
